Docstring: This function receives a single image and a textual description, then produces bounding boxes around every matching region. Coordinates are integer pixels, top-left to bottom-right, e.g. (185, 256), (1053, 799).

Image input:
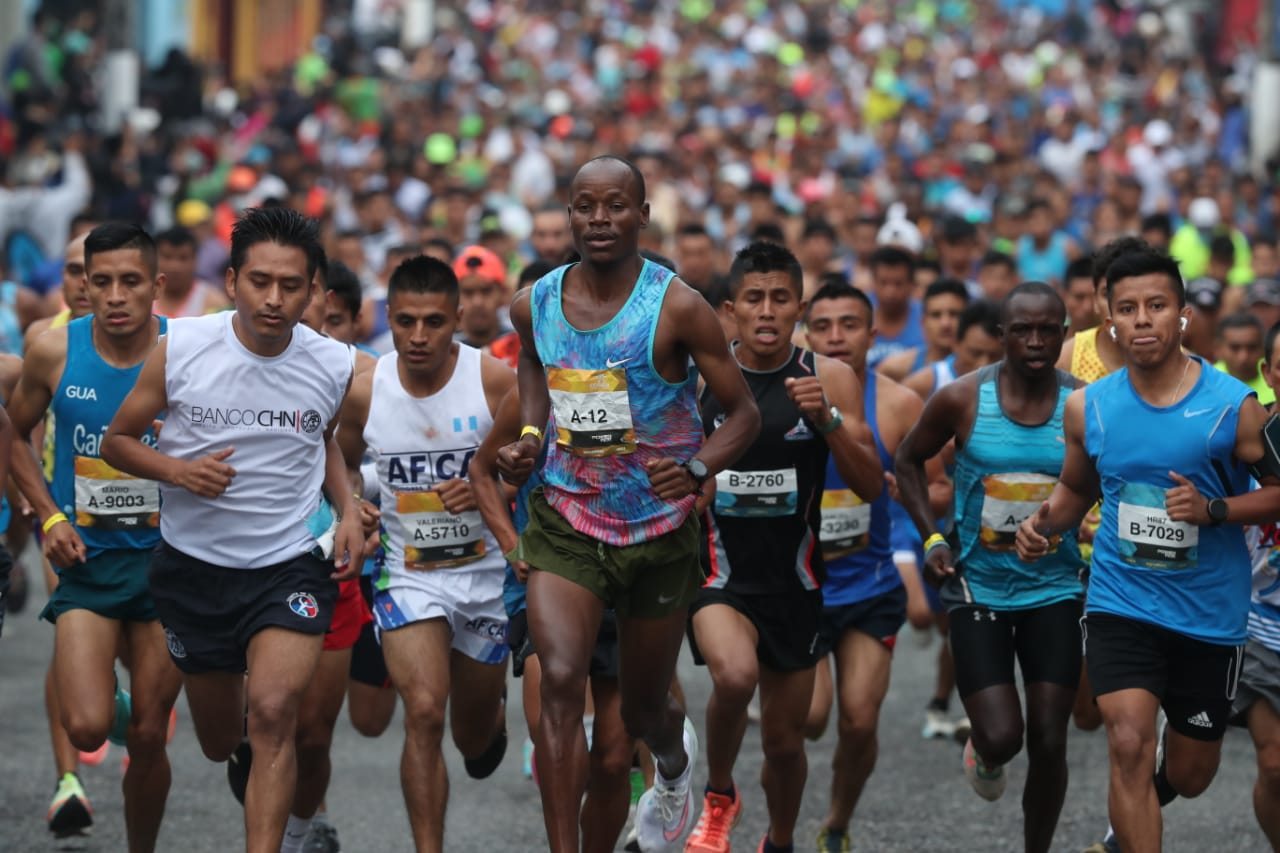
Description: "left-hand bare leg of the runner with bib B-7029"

(1098, 688), (1162, 853)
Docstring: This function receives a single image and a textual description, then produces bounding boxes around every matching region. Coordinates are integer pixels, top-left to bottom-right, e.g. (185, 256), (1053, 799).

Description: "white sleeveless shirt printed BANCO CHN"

(159, 311), (355, 569)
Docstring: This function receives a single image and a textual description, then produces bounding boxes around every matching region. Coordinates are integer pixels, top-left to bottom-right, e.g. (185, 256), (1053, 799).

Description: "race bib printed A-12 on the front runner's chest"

(547, 368), (636, 457)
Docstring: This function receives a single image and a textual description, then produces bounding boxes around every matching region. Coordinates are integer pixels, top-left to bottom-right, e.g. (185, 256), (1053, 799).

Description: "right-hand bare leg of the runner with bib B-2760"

(760, 666), (813, 847)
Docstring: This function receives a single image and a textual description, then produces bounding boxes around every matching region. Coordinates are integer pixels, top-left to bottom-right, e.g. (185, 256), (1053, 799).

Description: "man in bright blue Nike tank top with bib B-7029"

(1018, 242), (1280, 852)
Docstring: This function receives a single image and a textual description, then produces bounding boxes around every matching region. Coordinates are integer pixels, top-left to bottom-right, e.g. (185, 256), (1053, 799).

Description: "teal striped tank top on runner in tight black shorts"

(954, 361), (1084, 610)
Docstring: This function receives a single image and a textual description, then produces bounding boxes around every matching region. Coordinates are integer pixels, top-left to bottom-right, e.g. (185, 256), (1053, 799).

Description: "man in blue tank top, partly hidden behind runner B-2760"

(805, 284), (950, 850)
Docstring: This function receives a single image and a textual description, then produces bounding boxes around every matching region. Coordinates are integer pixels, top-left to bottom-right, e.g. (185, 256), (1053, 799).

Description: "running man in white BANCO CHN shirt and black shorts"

(102, 207), (364, 850)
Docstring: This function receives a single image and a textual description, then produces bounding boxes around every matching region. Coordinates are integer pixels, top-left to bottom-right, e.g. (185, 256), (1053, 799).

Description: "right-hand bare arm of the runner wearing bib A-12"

(663, 283), (760, 476)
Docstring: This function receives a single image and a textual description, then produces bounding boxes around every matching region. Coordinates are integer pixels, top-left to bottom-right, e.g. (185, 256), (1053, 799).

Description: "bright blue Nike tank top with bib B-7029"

(1084, 357), (1253, 646)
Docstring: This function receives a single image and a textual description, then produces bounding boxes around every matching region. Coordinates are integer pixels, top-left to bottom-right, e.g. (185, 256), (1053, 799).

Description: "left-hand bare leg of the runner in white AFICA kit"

(383, 619), (455, 853)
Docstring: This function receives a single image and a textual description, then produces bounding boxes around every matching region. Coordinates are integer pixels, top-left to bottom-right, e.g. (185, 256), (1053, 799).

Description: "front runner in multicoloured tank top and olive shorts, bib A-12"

(498, 156), (759, 853)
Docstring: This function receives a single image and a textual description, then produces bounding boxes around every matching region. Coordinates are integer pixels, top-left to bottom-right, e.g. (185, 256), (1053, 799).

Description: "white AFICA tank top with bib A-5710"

(365, 343), (506, 571)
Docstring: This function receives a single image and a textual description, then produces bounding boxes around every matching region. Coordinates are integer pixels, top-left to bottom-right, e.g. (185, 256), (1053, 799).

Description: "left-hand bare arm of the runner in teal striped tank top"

(893, 379), (974, 539)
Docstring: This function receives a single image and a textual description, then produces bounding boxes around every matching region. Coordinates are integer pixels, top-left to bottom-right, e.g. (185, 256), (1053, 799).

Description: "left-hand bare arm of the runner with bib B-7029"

(1016, 388), (1101, 560)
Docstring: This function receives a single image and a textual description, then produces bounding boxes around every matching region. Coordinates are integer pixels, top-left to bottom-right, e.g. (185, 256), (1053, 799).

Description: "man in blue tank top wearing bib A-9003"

(9, 223), (182, 850)
